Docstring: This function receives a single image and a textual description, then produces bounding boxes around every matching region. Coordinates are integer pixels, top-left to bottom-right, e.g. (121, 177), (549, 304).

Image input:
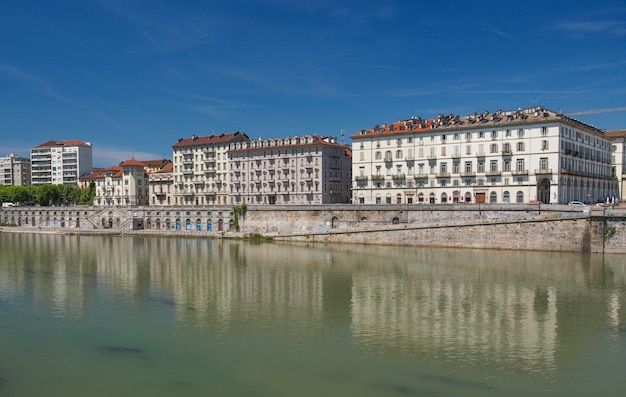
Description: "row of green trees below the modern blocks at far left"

(0, 183), (96, 205)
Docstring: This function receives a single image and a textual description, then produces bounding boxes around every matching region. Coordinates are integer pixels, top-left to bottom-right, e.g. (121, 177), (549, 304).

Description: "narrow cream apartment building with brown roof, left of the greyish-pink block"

(172, 132), (250, 205)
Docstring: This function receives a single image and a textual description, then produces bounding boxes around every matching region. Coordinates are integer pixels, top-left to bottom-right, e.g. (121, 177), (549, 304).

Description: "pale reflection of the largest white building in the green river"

(352, 273), (557, 372)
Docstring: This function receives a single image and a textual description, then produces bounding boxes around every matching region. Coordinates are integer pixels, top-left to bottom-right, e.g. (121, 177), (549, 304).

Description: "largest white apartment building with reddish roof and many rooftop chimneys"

(351, 107), (617, 204)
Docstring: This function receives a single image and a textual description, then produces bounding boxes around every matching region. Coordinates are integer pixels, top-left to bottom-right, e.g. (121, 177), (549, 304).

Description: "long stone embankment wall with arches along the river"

(0, 204), (626, 253)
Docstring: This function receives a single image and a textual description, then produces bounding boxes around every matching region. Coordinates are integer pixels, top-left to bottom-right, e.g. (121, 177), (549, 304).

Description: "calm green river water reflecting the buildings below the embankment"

(0, 233), (626, 397)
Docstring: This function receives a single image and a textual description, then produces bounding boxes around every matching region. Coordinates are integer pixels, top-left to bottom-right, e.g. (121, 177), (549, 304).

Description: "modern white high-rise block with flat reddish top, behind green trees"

(30, 140), (93, 185)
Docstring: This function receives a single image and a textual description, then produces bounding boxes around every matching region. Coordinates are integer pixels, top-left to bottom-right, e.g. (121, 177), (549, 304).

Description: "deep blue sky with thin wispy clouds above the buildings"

(0, 0), (626, 166)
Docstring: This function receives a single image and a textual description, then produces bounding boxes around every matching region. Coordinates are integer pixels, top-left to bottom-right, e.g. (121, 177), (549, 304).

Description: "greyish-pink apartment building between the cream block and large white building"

(228, 135), (352, 205)
